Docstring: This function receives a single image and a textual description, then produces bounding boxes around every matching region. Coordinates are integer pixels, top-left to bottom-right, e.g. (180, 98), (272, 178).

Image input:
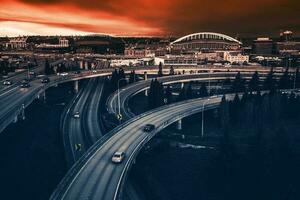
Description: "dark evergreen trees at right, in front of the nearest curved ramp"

(219, 92), (300, 133)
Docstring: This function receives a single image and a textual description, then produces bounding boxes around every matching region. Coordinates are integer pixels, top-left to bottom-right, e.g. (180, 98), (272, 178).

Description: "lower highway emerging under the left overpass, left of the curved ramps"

(61, 78), (103, 166)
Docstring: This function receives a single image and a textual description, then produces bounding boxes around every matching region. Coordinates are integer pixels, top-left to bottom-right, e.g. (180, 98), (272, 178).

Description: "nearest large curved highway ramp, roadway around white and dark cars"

(51, 95), (234, 200)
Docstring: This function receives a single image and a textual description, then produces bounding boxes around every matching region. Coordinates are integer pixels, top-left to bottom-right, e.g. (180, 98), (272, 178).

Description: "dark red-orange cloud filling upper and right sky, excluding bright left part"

(0, 0), (300, 35)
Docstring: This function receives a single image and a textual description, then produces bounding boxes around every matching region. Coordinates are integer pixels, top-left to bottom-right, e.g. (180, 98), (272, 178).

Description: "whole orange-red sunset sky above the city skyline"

(0, 0), (300, 36)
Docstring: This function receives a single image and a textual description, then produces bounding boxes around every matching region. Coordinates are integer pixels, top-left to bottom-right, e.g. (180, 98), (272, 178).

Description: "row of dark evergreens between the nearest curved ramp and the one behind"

(148, 69), (300, 109)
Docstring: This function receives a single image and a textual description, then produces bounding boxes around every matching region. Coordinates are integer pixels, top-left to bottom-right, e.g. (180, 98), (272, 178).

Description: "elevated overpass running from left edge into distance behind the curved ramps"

(0, 67), (280, 133)
